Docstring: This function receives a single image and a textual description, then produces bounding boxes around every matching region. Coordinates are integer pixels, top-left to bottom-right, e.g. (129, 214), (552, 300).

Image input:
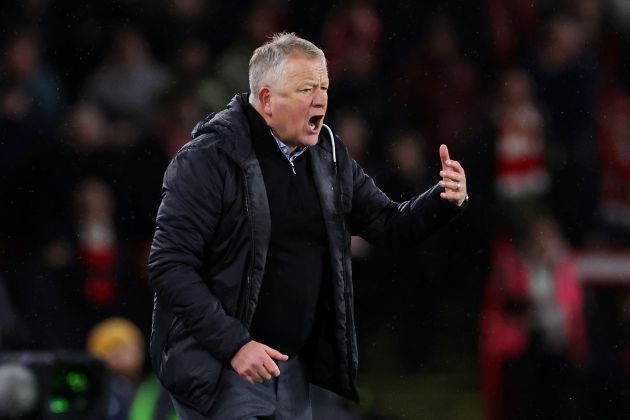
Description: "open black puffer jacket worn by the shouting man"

(149, 95), (460, 413)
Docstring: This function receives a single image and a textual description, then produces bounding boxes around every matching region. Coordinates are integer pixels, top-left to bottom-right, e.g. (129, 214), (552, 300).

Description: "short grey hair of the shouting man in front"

(249, 32), (326, 104)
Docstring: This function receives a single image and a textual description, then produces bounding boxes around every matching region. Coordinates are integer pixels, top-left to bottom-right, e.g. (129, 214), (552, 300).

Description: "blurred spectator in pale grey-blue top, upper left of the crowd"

(83, 28), (169, 127)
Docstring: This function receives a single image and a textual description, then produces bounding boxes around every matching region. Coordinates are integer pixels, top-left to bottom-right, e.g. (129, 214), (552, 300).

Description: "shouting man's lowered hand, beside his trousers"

(230, 340), (289, 384)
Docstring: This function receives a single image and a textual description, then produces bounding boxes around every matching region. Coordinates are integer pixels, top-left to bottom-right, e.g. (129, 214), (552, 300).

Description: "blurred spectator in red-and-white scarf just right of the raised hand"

(461, 68), (552, 246)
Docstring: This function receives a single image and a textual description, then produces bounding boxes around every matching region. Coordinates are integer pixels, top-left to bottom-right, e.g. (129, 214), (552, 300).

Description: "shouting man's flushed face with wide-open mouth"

(264, 55), (329, 148)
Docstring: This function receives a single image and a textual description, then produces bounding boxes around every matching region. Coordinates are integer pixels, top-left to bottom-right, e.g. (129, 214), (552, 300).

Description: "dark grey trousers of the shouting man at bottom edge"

(173, 357), (313, 420)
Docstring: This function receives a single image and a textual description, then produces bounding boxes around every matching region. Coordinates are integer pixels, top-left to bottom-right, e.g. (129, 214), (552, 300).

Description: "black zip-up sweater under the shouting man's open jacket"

(247, 106), (330, 356)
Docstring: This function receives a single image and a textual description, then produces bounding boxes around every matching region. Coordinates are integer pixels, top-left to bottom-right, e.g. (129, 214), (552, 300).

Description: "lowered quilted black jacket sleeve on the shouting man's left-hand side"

(149, 146), (249, 364)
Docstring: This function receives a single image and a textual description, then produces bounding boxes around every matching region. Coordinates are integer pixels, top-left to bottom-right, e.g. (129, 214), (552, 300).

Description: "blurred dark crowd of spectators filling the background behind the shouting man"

(0, 0), (630, 420)
